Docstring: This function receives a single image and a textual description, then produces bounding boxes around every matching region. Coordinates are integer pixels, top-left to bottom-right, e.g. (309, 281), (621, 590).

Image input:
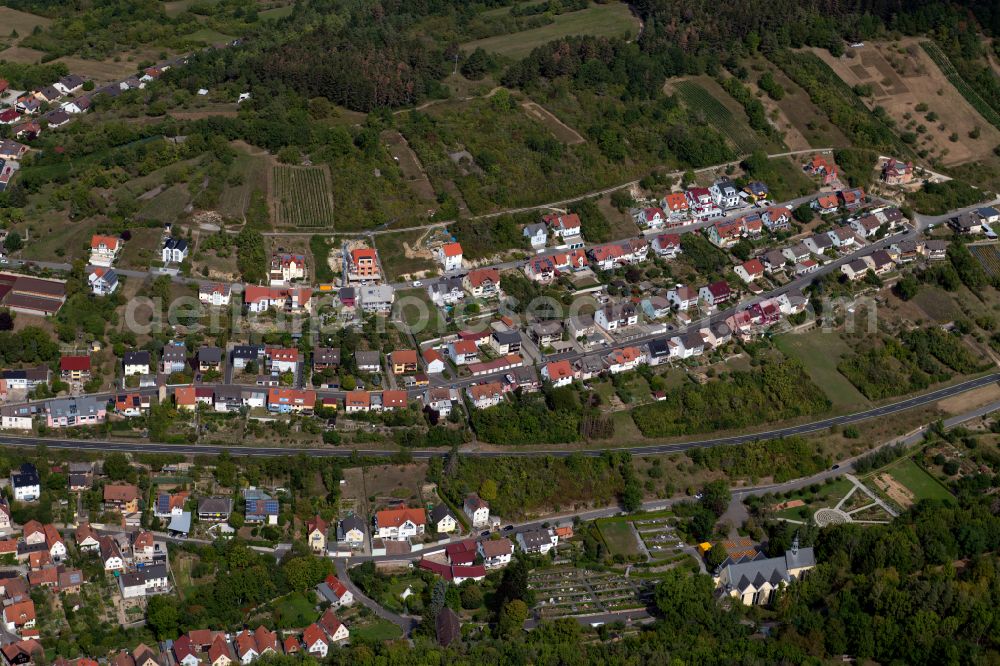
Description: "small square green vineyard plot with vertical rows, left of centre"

(273, 166), (333, 227)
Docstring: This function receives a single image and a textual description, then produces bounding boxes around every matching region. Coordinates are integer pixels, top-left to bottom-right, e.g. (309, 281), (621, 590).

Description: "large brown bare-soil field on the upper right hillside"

(813, 39), (1000, 165)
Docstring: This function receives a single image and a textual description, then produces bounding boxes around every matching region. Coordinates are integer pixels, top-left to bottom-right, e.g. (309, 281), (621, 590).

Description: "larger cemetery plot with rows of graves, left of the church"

(528, 567), (653, 619)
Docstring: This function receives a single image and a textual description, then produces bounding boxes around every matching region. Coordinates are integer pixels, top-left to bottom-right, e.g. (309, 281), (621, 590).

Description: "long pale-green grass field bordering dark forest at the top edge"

(462, 2), (639, 59)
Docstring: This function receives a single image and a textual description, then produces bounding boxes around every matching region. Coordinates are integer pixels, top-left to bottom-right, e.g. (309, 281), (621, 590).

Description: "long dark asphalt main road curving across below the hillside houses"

(0, 372), (1000, 459)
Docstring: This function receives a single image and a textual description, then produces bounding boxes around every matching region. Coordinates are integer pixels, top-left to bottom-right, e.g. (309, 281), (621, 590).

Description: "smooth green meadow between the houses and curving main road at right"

(774, 329), (868, 410)
